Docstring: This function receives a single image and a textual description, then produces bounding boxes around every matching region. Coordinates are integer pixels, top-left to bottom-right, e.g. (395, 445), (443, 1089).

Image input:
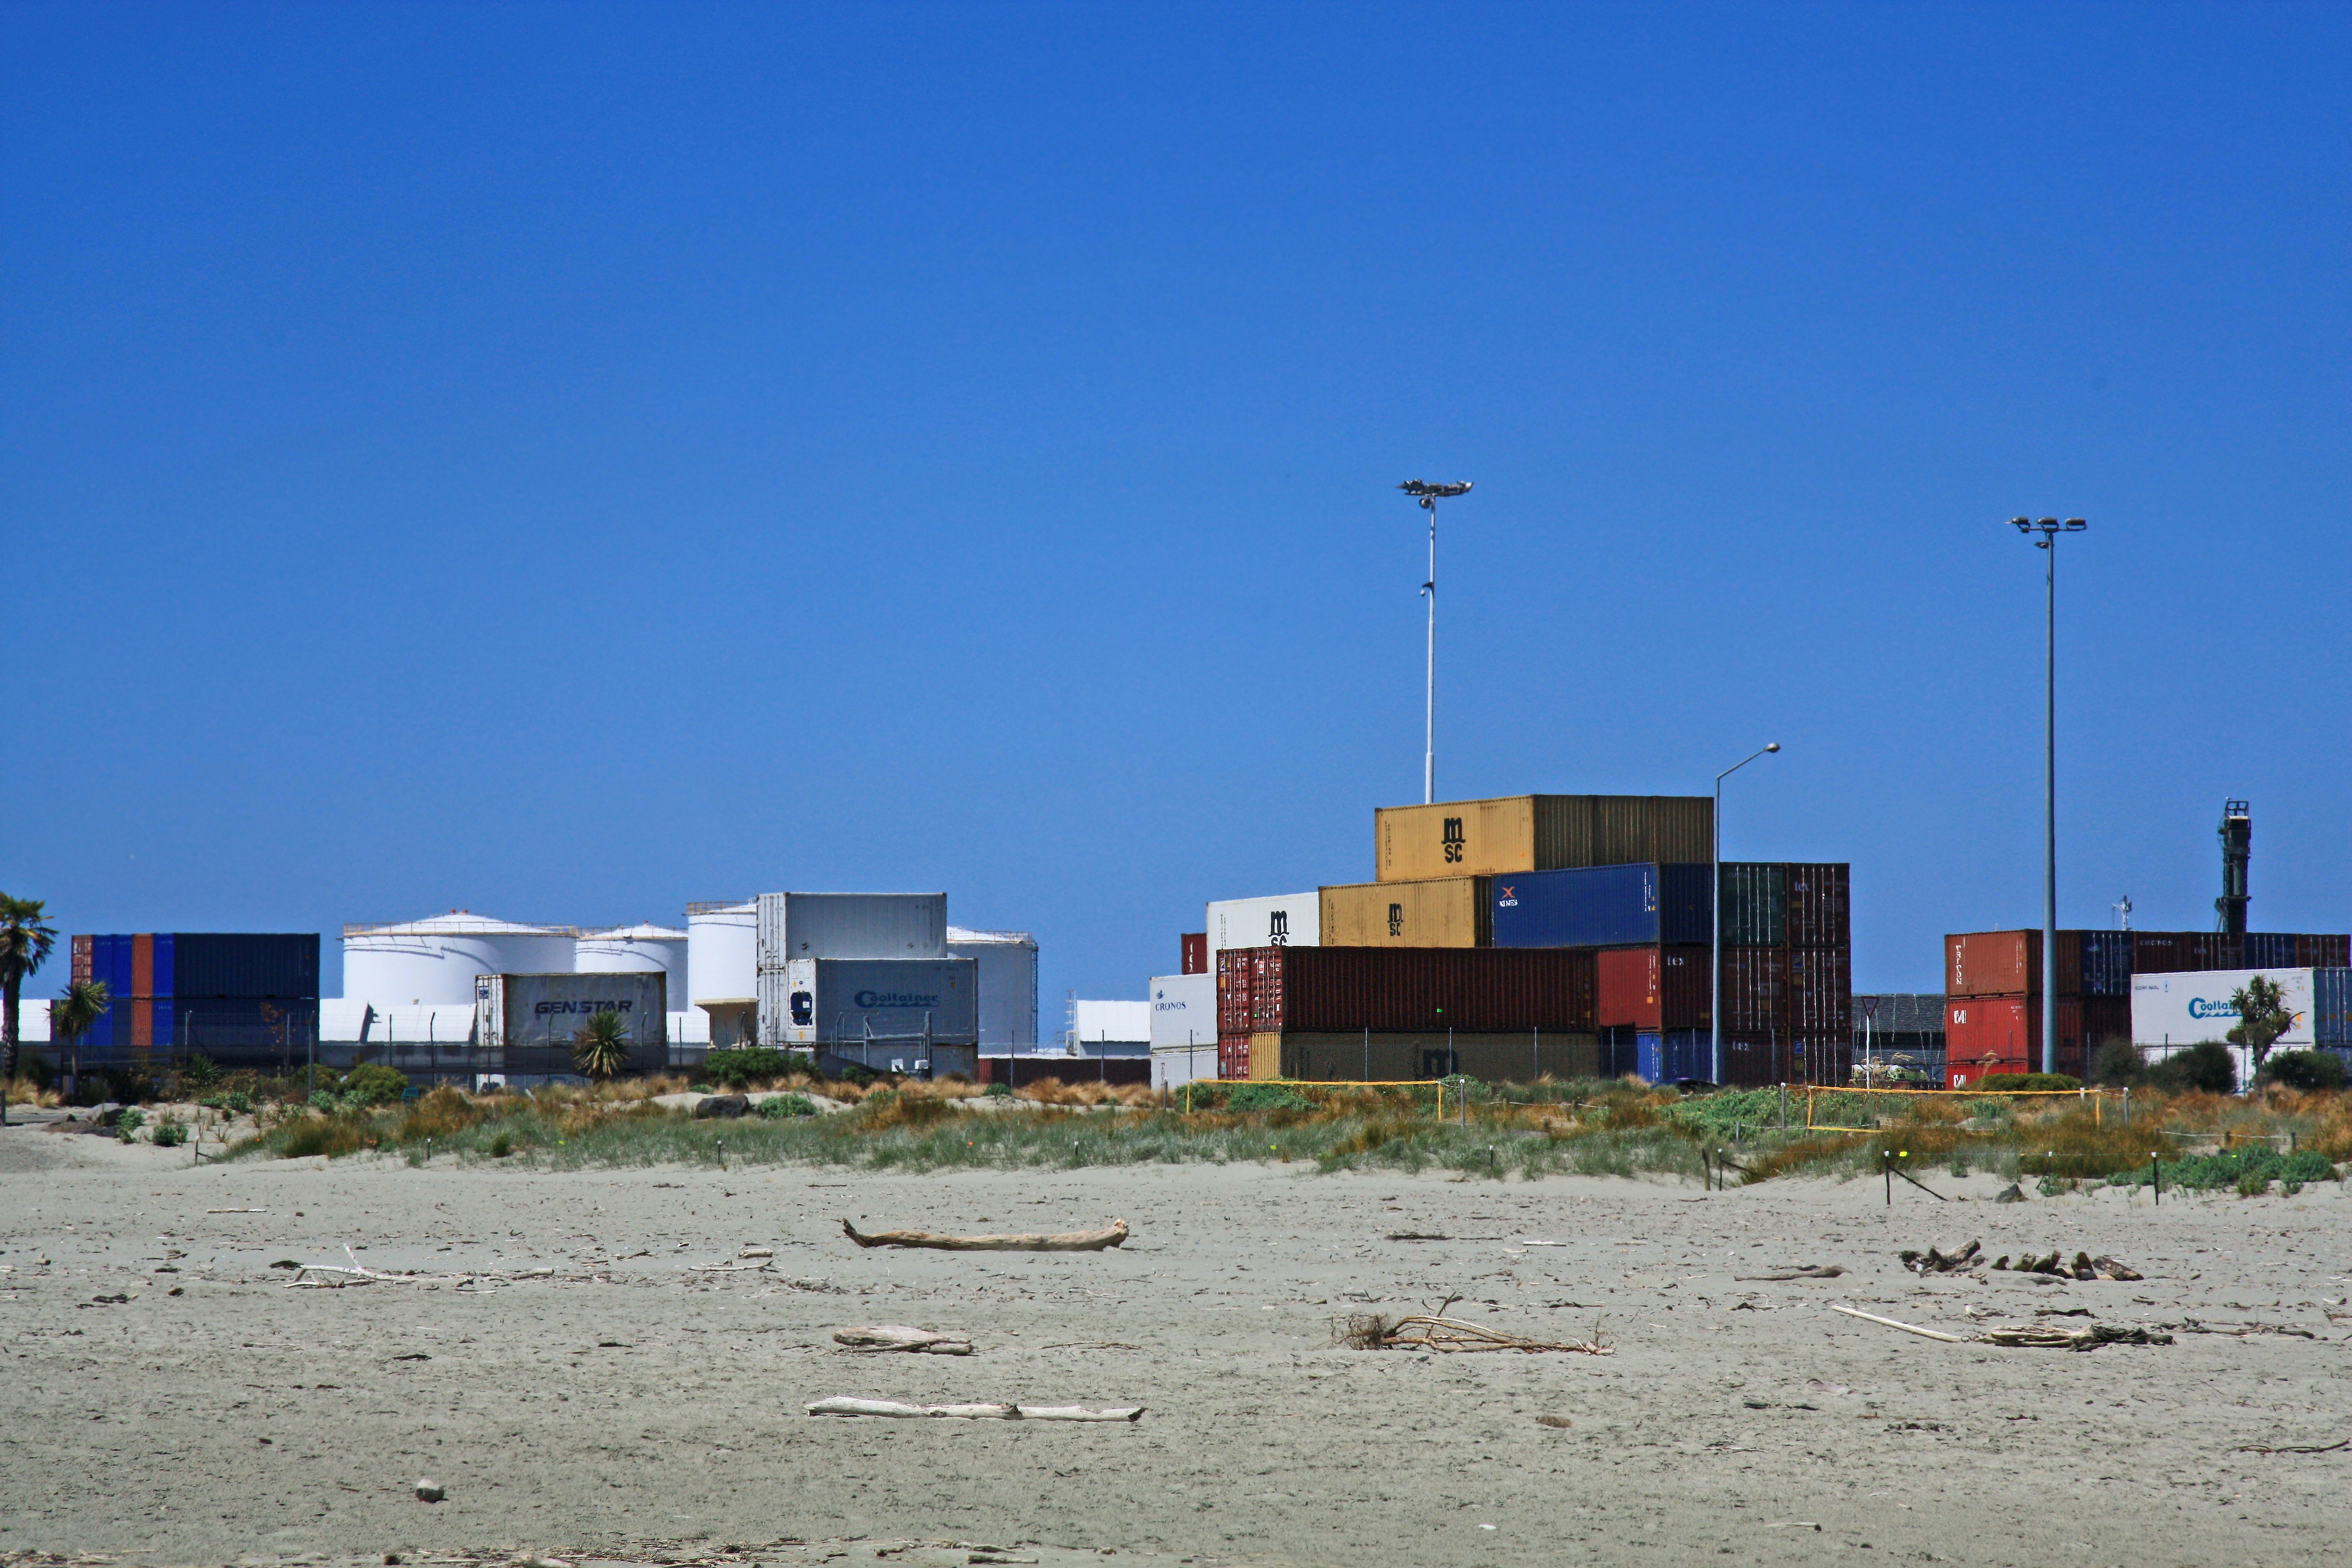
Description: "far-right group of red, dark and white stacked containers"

(1943, 931), (2352, 1088)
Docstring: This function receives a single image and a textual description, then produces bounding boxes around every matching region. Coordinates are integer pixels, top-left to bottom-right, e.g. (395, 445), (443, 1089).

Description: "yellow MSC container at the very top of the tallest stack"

(1373, 794), (1714, 884)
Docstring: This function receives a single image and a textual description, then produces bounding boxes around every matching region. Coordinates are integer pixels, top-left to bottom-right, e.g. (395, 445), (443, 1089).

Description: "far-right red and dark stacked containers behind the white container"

(1943, 931), (2352, 1088)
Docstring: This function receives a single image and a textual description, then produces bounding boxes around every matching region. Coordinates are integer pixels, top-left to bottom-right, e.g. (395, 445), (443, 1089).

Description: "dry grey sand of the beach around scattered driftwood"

(0, 1129), (2352, 1566)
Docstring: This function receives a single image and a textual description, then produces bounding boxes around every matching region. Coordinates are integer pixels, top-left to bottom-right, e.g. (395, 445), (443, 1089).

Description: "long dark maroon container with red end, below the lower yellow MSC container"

(1216, 948), (1594, 1035)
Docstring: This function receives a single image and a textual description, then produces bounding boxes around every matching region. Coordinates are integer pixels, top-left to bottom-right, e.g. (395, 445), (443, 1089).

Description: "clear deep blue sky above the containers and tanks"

(0, 5), (2352, 1006)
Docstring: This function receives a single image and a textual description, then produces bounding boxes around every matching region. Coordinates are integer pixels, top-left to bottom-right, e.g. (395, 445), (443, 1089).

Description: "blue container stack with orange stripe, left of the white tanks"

(73, 931), (318, 1072)
